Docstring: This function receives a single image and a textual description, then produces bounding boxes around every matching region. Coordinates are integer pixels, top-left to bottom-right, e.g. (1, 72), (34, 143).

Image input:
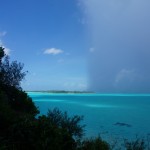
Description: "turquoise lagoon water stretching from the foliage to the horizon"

(28, 92), (150, 141)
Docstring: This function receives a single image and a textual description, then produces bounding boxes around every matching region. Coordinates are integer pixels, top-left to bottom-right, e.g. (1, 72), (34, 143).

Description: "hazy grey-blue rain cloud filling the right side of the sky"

(80, 0), (150, 93)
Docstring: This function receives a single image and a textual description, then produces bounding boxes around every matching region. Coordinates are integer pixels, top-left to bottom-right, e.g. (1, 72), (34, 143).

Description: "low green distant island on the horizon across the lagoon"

(26, 90), (94, 94)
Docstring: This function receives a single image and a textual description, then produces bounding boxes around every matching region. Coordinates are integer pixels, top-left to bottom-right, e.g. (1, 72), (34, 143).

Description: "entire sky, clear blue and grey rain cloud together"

(0, 0), (150, 93)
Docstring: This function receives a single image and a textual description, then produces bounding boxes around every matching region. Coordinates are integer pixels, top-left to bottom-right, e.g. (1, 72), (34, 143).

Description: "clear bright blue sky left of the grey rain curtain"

(0, 0), (88, 90)
